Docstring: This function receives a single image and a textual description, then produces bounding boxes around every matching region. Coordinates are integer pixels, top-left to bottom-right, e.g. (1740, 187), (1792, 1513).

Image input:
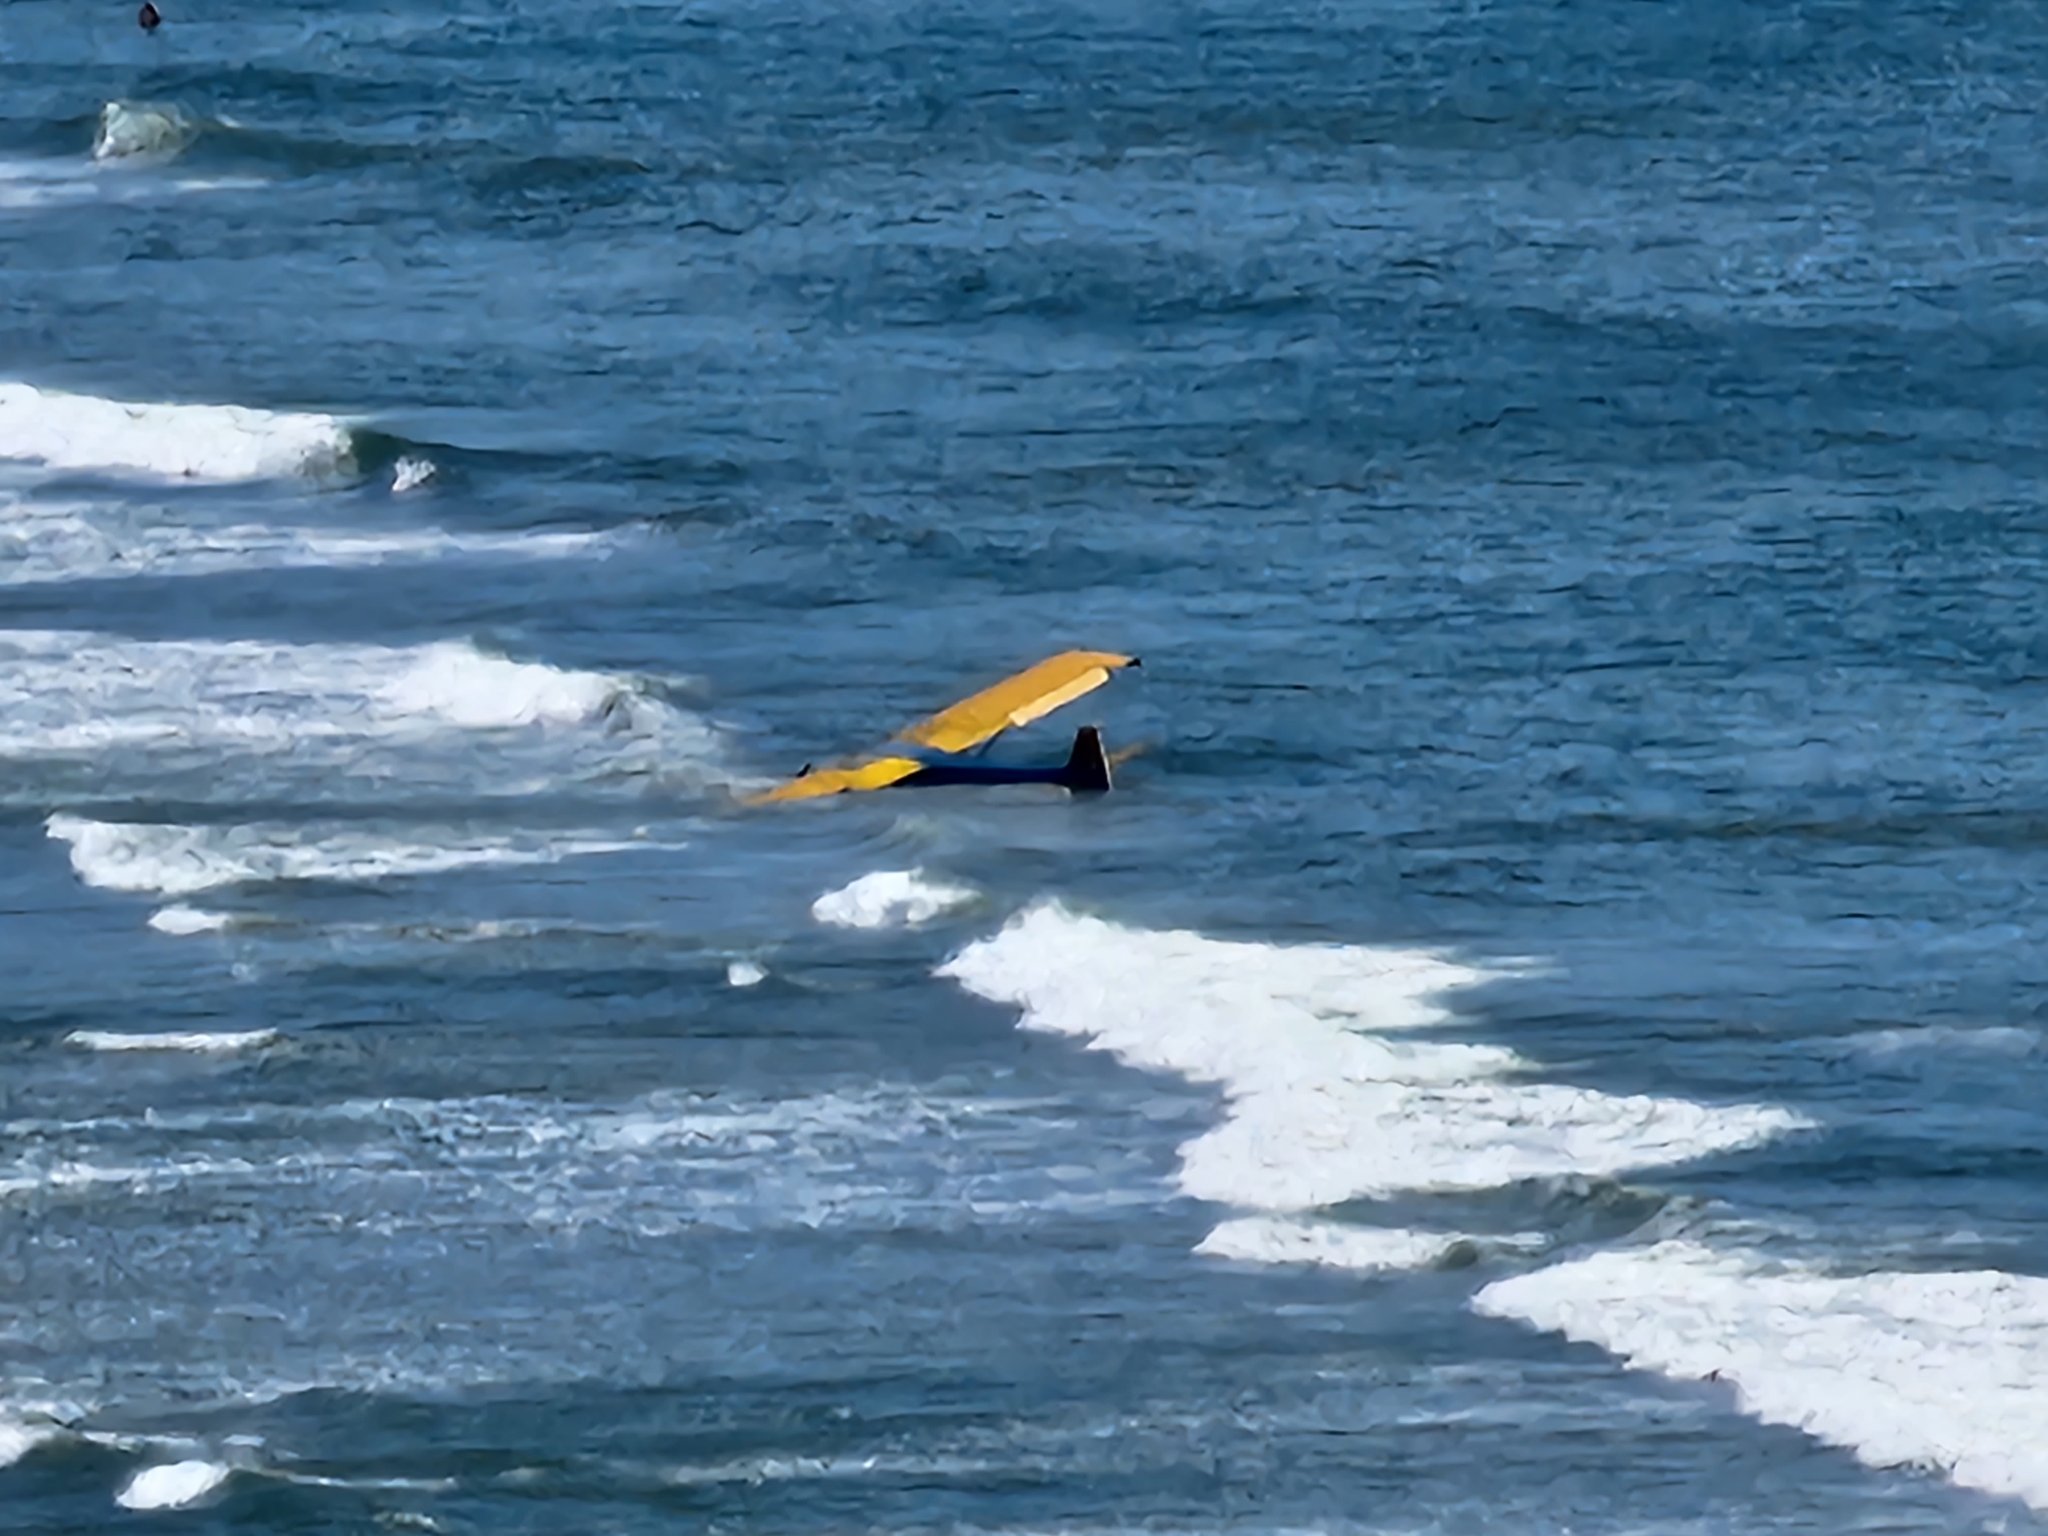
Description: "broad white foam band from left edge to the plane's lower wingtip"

(0, 631), (679, 758)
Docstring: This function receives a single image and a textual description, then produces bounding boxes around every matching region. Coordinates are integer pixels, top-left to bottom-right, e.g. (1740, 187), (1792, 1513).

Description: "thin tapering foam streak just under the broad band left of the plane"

(47, 815), (674, 897)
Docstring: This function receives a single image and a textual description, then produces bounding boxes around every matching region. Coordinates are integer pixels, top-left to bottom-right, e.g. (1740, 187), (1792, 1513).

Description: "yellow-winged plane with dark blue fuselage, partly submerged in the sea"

(748, 651), (1139, 805)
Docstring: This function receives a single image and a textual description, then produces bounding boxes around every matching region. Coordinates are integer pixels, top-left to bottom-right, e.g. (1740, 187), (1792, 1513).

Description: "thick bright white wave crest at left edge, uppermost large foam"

(0, 381), (352, 481)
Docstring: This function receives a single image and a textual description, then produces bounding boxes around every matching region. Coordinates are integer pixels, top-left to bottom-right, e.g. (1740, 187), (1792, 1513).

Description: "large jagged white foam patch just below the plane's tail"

(940, 905), (1806, 1212)
